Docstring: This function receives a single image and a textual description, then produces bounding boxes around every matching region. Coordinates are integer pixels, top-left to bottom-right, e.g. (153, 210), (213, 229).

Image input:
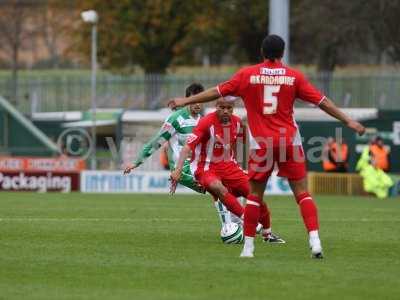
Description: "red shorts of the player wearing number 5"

(248, 145), (307, 181)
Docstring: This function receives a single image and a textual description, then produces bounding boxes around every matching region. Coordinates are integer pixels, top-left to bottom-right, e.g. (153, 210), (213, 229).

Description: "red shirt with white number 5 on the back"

(218, 60), (325, 149)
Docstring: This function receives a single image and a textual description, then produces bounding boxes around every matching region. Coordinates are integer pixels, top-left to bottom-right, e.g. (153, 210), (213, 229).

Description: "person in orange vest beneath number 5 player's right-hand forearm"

(322, 137), (349, 173)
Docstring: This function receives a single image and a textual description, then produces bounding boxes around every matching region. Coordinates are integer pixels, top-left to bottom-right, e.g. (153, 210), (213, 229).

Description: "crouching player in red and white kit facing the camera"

(171, 98), (285, 243)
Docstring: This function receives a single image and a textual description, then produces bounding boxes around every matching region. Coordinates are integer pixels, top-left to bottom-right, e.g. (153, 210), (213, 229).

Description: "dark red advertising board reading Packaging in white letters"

(0, 171), (80, 193)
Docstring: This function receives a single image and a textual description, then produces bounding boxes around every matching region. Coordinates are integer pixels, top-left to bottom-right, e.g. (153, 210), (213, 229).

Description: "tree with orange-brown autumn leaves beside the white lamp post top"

(80, 0), (200, 74)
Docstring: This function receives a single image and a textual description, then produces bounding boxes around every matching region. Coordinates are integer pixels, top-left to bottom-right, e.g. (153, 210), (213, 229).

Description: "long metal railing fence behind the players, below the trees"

(0, 74), (400, 114)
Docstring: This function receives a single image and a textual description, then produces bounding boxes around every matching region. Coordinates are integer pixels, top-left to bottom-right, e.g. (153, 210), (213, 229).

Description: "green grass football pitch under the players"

(0, 193), (400, 299)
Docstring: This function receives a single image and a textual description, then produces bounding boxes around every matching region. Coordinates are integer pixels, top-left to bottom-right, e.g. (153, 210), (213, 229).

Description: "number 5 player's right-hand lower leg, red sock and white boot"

(289, 178), (322, 258)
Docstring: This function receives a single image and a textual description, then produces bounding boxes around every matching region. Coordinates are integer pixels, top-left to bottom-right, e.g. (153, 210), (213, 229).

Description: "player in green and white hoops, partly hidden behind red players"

(124, 83), (238, 226)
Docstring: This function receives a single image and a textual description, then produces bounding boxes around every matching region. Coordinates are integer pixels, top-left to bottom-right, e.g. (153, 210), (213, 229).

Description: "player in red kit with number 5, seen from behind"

(169, 35), (365, 258)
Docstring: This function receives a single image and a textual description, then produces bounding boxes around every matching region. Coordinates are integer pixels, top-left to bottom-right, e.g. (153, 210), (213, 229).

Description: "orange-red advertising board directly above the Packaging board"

(0, 156), (86, 172)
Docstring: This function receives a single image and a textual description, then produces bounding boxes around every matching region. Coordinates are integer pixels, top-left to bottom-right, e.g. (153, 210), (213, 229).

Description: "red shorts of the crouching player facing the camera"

(195, 162), (250, 197)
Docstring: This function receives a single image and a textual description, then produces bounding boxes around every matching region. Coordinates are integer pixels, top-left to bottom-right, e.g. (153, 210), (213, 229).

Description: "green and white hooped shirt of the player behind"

(134, 107), (201, 167)
